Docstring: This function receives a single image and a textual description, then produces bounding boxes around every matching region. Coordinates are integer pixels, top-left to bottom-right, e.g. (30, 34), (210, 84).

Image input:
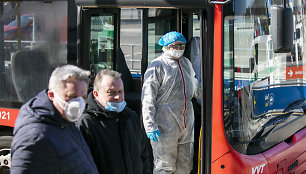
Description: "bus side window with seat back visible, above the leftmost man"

(0, 1), (67, 104)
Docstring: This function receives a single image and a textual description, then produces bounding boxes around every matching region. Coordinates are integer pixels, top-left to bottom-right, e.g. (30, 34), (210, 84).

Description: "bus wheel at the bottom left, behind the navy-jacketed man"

(0, 136), (13, 174)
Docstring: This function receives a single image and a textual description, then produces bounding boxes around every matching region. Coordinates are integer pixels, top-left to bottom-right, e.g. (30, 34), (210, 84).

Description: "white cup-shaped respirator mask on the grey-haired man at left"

(54, 93), (86, 122)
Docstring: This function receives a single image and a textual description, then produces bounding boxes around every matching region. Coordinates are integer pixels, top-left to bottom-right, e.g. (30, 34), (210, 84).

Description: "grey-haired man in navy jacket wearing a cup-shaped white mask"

(11, 65), (98, 174)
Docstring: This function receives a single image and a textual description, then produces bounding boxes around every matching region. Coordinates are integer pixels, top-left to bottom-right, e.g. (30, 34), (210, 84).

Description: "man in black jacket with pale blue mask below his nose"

(78, 70), (152, 174)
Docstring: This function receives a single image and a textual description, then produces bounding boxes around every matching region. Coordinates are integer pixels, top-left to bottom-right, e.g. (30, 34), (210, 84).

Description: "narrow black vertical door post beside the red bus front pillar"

(200, 8), (214, 174)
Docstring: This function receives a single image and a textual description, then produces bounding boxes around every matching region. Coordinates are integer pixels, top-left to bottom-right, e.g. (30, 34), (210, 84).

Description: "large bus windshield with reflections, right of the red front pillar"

(223, 0), (306, 154)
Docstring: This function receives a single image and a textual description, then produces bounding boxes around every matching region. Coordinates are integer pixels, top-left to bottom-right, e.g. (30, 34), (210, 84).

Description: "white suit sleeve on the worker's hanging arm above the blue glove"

(141, 61), (162, 132)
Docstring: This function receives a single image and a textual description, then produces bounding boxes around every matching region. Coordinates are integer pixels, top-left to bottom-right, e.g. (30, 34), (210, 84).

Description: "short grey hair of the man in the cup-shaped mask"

(49, 65), (90, 91)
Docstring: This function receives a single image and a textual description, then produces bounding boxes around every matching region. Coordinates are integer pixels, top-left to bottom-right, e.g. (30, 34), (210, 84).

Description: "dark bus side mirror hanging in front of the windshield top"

(271, 5), (293, 53)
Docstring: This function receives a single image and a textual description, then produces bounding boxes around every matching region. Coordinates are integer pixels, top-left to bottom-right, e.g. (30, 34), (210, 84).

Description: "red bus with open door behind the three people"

(0, 0), (306, 174)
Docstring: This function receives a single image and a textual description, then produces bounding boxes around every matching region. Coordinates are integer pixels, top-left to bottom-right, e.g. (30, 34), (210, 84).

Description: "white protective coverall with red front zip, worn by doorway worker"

(142, 53), (201, 174)
